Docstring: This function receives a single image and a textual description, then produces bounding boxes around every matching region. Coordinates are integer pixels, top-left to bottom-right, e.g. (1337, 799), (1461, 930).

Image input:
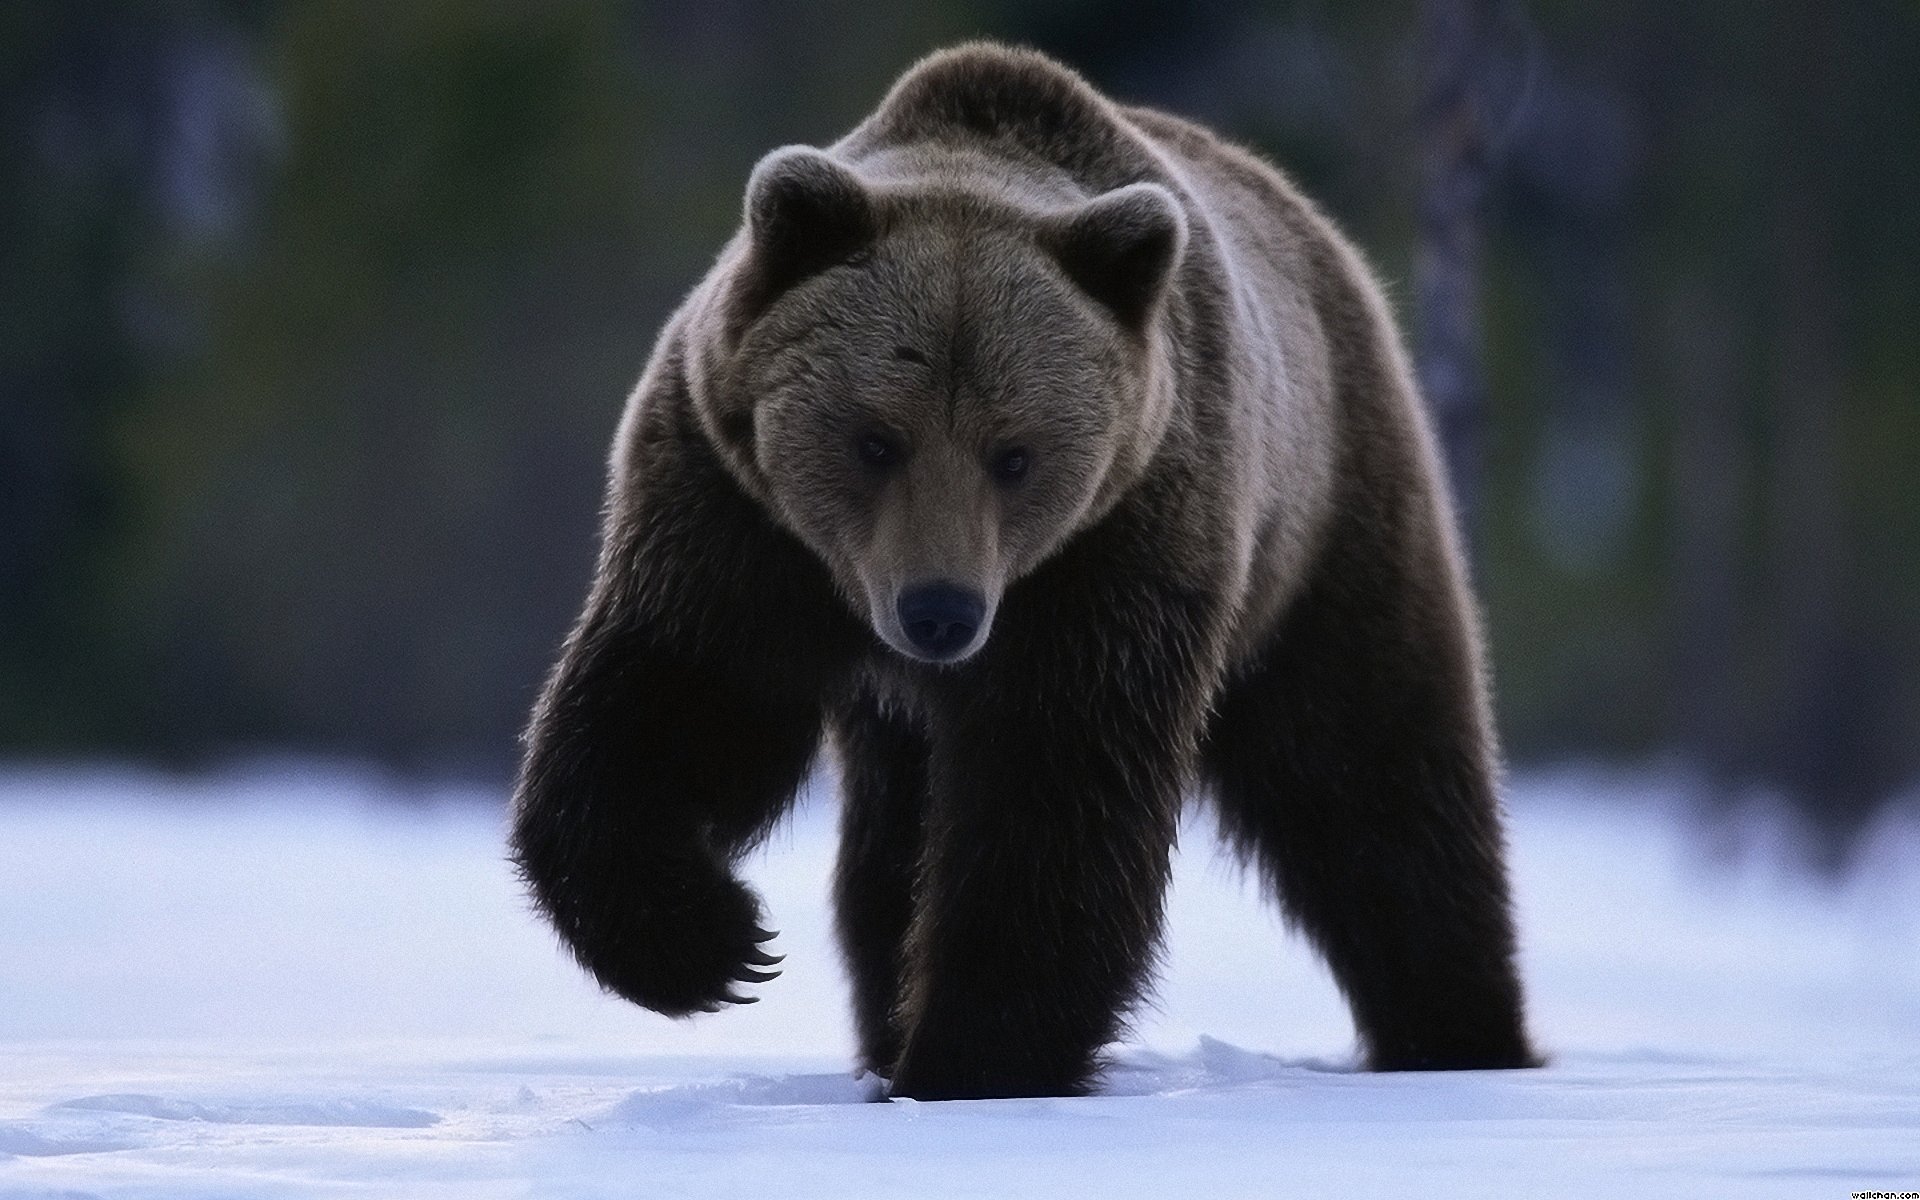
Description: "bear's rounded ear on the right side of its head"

(1044, 182), (1187, 328)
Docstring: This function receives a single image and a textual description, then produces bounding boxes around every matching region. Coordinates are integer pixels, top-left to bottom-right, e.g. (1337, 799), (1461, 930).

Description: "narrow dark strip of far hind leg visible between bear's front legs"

(833, 695), (927, 1075)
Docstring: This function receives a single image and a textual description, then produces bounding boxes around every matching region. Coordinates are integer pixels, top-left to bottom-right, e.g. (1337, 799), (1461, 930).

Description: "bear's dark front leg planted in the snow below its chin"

(893, 560), (1212, 1100)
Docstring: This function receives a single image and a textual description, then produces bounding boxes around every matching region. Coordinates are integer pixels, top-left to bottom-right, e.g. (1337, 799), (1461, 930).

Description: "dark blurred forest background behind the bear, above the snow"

(0, 0), (1920, 858)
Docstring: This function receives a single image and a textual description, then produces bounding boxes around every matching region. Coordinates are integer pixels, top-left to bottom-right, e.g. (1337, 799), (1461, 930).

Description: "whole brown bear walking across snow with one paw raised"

(513, 44), (1534, 1098)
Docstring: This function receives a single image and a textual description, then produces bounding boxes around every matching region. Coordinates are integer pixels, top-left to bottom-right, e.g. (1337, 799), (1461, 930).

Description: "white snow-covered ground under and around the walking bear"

(0, 766), (1920, 1200)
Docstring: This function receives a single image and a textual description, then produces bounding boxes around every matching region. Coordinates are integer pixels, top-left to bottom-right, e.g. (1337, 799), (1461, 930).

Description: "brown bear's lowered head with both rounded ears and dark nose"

(689, 148), (1187, 662)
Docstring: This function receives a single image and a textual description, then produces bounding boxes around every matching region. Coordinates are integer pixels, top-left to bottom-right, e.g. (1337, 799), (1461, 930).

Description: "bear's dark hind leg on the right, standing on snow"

(1204, 536), (1536, 1069)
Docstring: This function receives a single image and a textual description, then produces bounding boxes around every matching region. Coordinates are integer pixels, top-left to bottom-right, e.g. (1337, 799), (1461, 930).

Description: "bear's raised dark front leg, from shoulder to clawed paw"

(513, 420), (858, 1016)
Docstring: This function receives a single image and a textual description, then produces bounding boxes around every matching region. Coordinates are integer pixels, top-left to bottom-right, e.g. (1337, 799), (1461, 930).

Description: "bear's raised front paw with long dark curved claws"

(584, 864), (783, 1018)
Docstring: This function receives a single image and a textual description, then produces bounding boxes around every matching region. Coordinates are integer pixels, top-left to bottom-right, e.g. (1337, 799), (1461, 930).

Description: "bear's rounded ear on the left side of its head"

(747, 146), (877, 305)
